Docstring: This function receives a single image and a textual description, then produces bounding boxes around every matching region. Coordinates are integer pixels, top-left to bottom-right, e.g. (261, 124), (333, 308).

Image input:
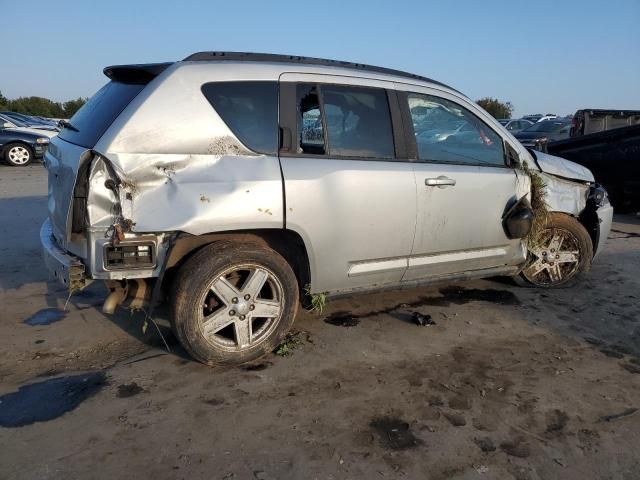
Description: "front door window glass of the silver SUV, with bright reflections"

(408, 94), (505, 166)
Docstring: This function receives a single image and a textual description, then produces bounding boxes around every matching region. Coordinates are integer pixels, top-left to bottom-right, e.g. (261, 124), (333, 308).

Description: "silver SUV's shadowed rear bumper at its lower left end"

(40, 219), (87, 291)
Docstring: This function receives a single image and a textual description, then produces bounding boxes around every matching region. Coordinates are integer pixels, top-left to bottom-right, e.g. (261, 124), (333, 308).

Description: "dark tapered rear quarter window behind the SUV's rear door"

(202, 82), (278, 155)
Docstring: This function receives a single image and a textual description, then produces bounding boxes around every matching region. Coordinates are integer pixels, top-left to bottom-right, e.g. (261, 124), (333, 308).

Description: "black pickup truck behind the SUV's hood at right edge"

(546, 109), (640, 212)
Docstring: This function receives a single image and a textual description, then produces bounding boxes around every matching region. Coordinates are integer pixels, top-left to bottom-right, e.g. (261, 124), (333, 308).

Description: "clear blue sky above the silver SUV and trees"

(0, 0), (640, 115)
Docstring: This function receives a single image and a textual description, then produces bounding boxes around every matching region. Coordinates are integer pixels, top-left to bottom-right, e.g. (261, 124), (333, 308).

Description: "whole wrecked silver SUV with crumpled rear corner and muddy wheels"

(41, 52), (613, 364)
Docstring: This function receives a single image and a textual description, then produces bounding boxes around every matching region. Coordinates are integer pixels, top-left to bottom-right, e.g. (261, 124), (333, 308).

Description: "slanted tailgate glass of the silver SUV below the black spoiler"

(58, 82), (145, 148)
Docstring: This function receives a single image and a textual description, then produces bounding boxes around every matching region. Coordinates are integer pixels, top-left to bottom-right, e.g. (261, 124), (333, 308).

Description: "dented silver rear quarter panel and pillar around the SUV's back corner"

(95, 62), (284, 235)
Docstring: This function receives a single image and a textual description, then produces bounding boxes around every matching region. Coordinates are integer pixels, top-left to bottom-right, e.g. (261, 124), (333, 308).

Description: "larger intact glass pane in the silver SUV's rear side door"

(321, 85), (394, 158)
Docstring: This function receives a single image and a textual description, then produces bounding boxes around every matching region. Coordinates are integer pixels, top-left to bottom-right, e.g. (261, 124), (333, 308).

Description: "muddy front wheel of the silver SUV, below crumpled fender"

(515, 213), (593, 288)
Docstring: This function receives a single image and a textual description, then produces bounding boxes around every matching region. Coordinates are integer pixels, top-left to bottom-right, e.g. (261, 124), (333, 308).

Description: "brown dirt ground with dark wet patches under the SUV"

(0, 164), (640, 480)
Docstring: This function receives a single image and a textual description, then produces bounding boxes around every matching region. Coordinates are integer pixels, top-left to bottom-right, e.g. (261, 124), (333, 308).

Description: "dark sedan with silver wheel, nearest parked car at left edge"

(0, 120), (49, 167)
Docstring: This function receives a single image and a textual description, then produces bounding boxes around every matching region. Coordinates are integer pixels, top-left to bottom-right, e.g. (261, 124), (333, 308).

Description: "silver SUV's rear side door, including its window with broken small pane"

(280, 73), (416, 292)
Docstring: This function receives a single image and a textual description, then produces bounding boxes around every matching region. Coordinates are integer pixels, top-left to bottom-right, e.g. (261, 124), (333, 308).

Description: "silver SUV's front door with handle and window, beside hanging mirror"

(400, 89), (525, 280)
